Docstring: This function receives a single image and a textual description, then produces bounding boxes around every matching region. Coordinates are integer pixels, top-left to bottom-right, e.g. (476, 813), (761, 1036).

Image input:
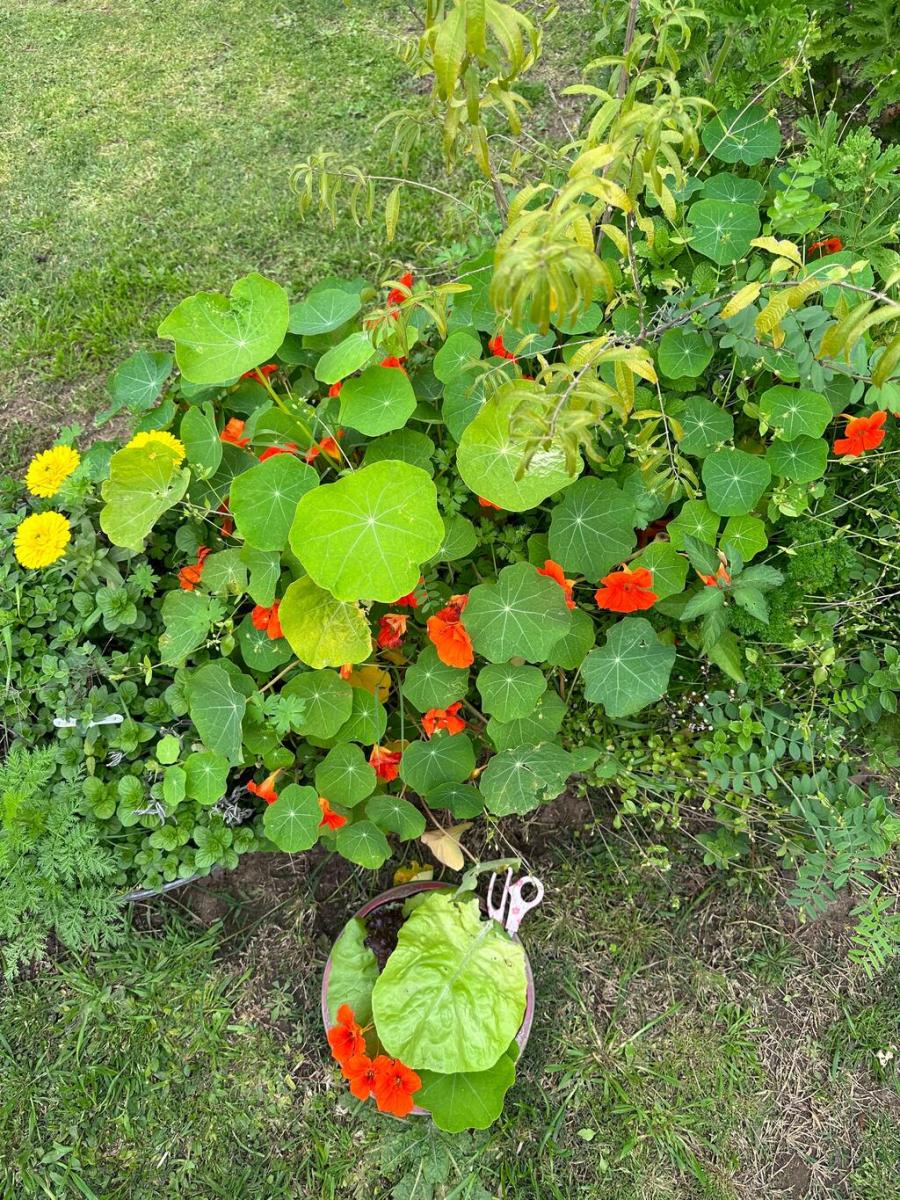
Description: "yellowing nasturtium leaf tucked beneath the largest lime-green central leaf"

(278, 576), (369, 668)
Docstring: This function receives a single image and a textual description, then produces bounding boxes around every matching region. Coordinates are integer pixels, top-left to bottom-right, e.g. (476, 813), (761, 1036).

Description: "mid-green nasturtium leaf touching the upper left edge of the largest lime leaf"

(229, 454), (319, 550)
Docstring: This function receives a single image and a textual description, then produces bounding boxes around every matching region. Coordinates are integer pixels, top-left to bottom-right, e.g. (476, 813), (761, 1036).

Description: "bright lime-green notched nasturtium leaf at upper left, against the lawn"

(156, 272), (289, 384)
